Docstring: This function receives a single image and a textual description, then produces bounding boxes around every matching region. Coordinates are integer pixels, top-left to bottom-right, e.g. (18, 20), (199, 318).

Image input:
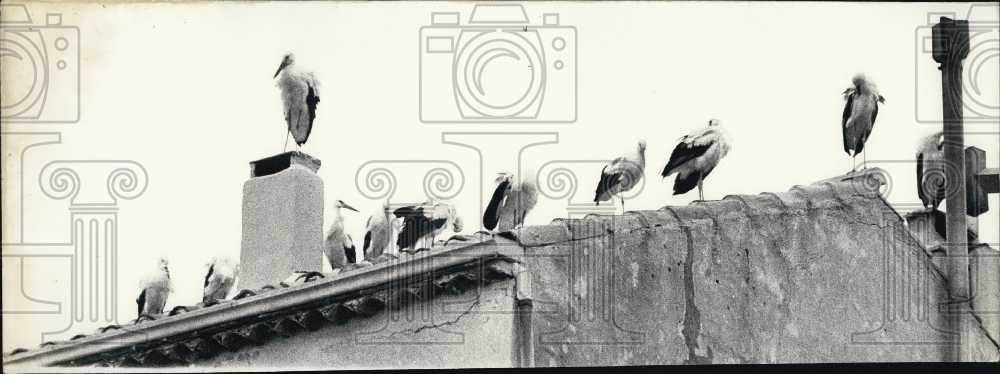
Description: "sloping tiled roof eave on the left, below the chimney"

(3, 238), (520, 367)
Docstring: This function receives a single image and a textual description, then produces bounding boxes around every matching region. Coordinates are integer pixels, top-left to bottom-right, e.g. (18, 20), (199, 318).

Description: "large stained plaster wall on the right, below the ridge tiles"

(518, 183), (998, 366)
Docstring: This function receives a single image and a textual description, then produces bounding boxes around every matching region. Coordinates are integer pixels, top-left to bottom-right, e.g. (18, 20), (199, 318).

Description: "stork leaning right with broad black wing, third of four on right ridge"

(660, 119), (730, 200)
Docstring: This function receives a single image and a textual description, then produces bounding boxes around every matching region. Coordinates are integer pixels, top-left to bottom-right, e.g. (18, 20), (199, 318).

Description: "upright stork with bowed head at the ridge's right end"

(841, 74), (885, 172)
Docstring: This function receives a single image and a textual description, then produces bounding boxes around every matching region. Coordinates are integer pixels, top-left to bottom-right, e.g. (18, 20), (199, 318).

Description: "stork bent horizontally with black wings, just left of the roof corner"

(393, 202), (462, 251)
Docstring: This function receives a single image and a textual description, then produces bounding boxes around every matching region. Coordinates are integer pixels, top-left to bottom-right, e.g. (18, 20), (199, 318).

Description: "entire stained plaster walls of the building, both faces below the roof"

(209, 177), (1000, 368)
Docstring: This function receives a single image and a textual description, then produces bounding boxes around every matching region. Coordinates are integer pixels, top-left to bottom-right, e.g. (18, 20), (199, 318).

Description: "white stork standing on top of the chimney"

(272, 53), (319, 152)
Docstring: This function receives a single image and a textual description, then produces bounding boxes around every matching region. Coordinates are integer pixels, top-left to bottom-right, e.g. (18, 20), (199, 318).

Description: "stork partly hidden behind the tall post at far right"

(917, 131), (945, 210)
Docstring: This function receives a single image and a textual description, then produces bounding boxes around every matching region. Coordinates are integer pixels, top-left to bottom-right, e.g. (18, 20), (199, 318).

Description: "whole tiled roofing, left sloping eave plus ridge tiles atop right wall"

(11, 169), (988, 367)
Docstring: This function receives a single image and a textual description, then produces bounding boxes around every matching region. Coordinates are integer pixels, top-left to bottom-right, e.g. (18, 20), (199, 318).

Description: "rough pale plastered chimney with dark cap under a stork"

(239, 151), (323, 289)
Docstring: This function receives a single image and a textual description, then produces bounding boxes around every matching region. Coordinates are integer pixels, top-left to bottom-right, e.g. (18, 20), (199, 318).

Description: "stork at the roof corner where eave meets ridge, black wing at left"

(483, 173), (538, 232)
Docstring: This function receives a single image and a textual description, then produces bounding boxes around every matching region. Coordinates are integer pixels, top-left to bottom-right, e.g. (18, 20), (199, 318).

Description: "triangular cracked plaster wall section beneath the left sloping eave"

(197, 280), (515, 370)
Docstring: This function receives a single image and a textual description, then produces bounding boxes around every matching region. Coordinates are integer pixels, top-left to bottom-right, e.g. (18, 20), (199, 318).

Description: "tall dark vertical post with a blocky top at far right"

(932, 17), (969, 361)
